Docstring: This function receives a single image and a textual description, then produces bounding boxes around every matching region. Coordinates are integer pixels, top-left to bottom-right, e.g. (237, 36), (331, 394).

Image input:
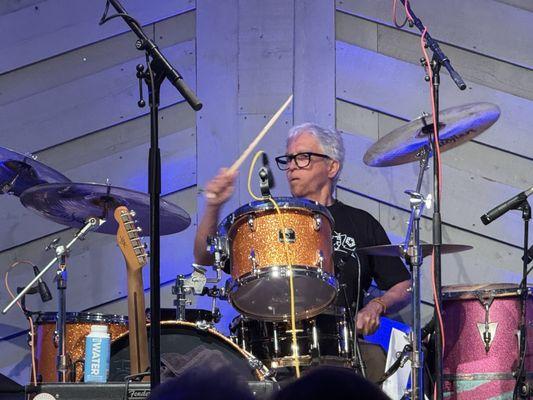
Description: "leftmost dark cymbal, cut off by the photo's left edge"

(0, 147), (70, 196)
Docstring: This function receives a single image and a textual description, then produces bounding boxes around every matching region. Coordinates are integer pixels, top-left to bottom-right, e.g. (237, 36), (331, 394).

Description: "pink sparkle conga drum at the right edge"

(442, 283), (533, 400)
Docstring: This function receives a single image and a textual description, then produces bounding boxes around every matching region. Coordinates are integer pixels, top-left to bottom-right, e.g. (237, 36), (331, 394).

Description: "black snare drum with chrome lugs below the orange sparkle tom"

(230, 308), (352, 369)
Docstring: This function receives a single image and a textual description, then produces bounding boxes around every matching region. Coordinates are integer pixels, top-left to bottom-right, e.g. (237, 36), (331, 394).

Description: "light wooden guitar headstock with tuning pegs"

(114, 206), (148, 270)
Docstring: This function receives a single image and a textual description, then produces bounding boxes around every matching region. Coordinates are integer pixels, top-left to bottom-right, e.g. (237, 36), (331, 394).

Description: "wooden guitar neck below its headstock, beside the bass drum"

(128, 268), (150, 374)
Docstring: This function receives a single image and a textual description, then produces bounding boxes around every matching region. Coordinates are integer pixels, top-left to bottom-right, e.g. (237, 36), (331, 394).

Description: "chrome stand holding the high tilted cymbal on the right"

(403, 147), (431, 400)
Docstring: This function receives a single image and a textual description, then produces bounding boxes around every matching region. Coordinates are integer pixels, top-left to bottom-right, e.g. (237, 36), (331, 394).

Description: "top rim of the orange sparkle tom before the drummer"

(218, 197), (335, 235)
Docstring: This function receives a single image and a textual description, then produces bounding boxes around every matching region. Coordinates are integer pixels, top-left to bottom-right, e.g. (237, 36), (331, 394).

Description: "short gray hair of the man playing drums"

(287, 122), (344, 187)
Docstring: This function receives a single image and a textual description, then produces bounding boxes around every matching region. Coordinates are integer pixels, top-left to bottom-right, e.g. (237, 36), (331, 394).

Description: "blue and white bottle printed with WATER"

(84, 325), (111, 382)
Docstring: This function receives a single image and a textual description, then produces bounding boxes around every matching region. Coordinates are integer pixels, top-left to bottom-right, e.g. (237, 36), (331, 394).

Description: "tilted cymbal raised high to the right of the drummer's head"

(363, 103), (500, 167)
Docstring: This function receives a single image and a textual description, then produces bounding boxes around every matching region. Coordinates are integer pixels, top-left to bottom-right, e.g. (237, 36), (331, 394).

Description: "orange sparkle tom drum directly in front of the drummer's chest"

(218, 198), (337, 321)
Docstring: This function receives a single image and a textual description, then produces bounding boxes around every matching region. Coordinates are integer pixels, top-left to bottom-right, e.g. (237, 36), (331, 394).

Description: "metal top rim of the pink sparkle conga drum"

(442, 283), (532, 300)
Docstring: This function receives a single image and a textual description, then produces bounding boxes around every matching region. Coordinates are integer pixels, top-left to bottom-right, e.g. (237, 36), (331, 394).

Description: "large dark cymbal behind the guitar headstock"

(20, 183), (191, 236)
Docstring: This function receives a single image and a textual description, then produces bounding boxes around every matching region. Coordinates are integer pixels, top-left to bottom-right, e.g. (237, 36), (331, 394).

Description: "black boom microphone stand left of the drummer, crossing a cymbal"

(100, 0), (202, 389)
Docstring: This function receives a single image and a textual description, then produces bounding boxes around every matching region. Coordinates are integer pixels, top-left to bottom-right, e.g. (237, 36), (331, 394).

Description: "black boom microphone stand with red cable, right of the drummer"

(400, 0), (466, 400)
